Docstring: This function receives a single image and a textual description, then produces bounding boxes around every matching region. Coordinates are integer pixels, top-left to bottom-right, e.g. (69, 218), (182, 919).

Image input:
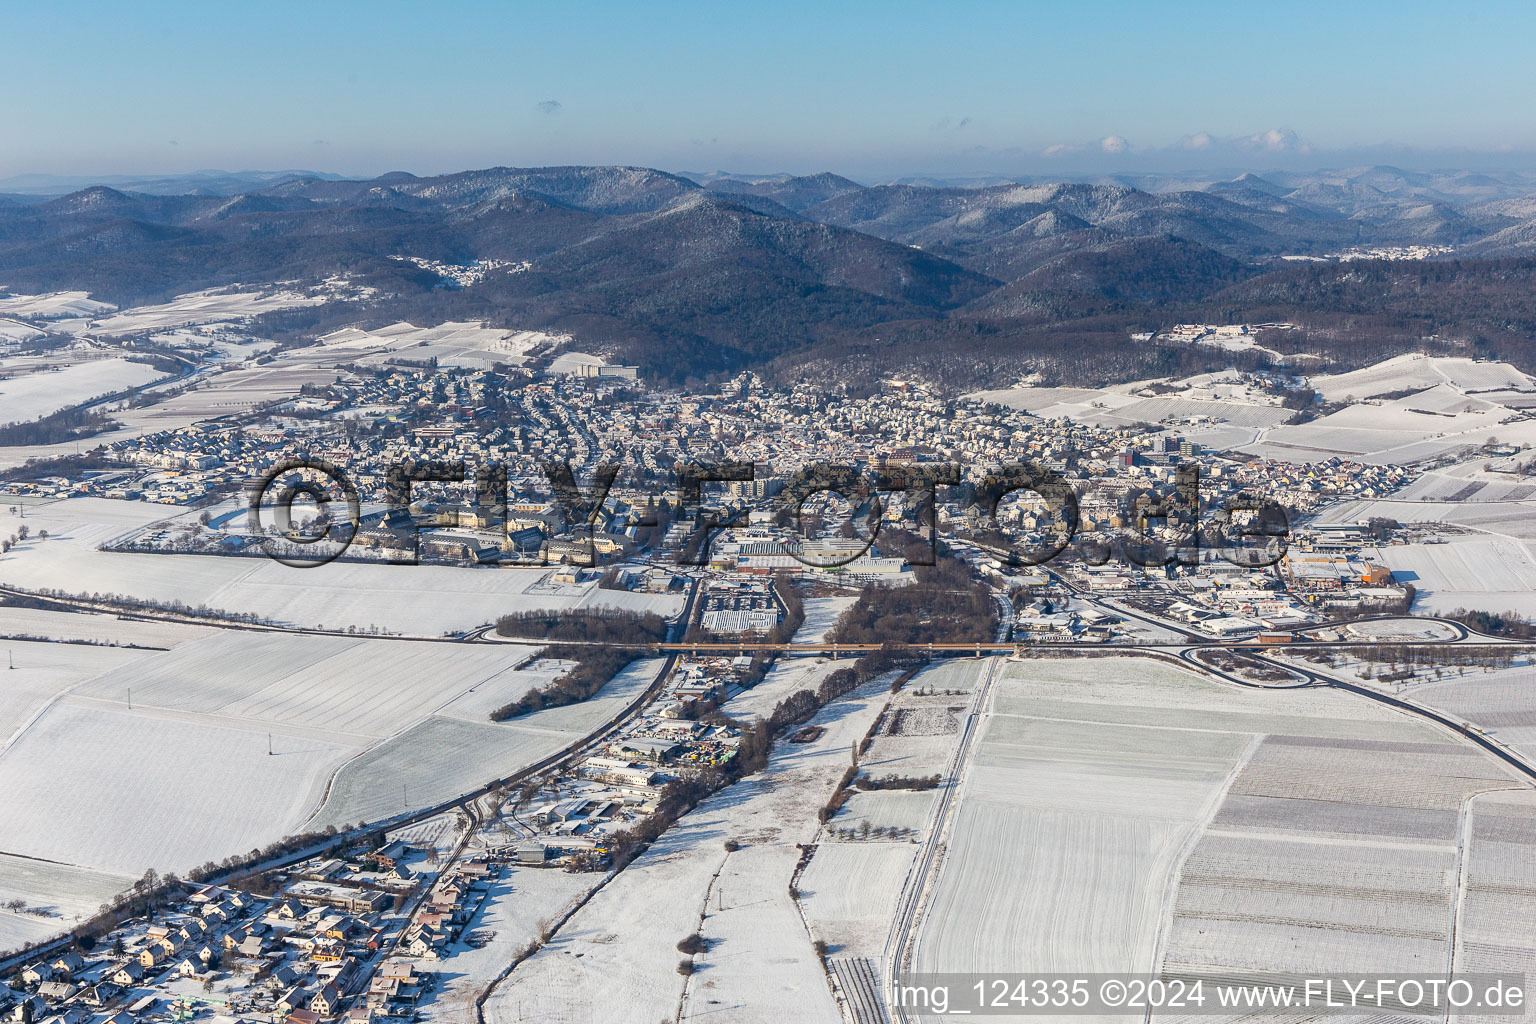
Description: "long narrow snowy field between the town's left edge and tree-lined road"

(0, 499), (684, 636)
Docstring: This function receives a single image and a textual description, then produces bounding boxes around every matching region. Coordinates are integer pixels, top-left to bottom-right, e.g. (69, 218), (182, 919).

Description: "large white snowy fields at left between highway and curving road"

(0, 631), (648, 877)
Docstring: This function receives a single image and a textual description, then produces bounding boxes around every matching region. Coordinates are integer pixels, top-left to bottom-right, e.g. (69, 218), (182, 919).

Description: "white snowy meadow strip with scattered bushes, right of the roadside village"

(485, 677), (886, 1024)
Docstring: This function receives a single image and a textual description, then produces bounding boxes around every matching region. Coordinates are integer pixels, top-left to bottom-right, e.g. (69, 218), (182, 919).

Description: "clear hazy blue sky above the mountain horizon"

(12, 0), (1536, 177)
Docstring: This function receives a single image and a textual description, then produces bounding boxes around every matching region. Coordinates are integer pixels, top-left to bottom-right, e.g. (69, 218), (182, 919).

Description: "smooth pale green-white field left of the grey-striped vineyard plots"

(914, 659), (1250, 972)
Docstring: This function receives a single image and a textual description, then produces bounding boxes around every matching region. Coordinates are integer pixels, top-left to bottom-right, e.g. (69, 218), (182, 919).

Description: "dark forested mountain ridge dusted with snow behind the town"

(9, 166), (1536, 386)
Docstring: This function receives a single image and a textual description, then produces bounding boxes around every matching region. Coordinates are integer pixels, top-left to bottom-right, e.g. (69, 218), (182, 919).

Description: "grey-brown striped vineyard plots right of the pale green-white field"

(1160, 706), (1521, 1000)
